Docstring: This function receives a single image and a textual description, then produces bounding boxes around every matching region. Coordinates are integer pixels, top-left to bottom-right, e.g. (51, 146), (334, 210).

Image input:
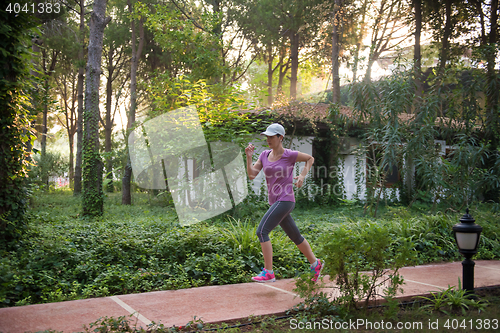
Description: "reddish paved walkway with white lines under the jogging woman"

(0, 260), (500, 333)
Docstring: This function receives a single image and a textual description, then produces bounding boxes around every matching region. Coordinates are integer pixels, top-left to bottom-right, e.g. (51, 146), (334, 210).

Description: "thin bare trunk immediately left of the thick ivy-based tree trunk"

(73, 0), (85, 195)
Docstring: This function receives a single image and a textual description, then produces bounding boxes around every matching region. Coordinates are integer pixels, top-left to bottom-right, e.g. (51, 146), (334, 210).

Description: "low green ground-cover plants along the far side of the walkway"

(0, 191), (500, 306)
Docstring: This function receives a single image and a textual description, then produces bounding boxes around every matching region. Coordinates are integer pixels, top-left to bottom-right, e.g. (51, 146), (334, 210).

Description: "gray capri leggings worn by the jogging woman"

(257, 201), (304, 245)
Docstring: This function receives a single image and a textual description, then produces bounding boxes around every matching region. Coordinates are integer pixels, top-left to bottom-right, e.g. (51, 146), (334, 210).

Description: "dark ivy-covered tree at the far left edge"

(0, 5), (35, 247)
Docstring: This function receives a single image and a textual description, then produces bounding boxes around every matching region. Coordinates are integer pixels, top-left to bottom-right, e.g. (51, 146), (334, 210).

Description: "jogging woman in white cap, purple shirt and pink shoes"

(245, 124), (323, 282)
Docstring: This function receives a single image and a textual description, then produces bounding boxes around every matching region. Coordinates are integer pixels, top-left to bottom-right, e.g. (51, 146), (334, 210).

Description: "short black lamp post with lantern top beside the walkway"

(453, 208), (483, 294)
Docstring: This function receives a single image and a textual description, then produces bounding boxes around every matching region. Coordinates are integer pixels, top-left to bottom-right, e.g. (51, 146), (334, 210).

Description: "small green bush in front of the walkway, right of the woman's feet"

(302, 221), (416, 308)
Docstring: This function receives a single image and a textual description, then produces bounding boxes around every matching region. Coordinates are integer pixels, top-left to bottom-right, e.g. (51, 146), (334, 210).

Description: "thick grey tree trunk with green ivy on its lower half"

(82, 0), (111, 217)
